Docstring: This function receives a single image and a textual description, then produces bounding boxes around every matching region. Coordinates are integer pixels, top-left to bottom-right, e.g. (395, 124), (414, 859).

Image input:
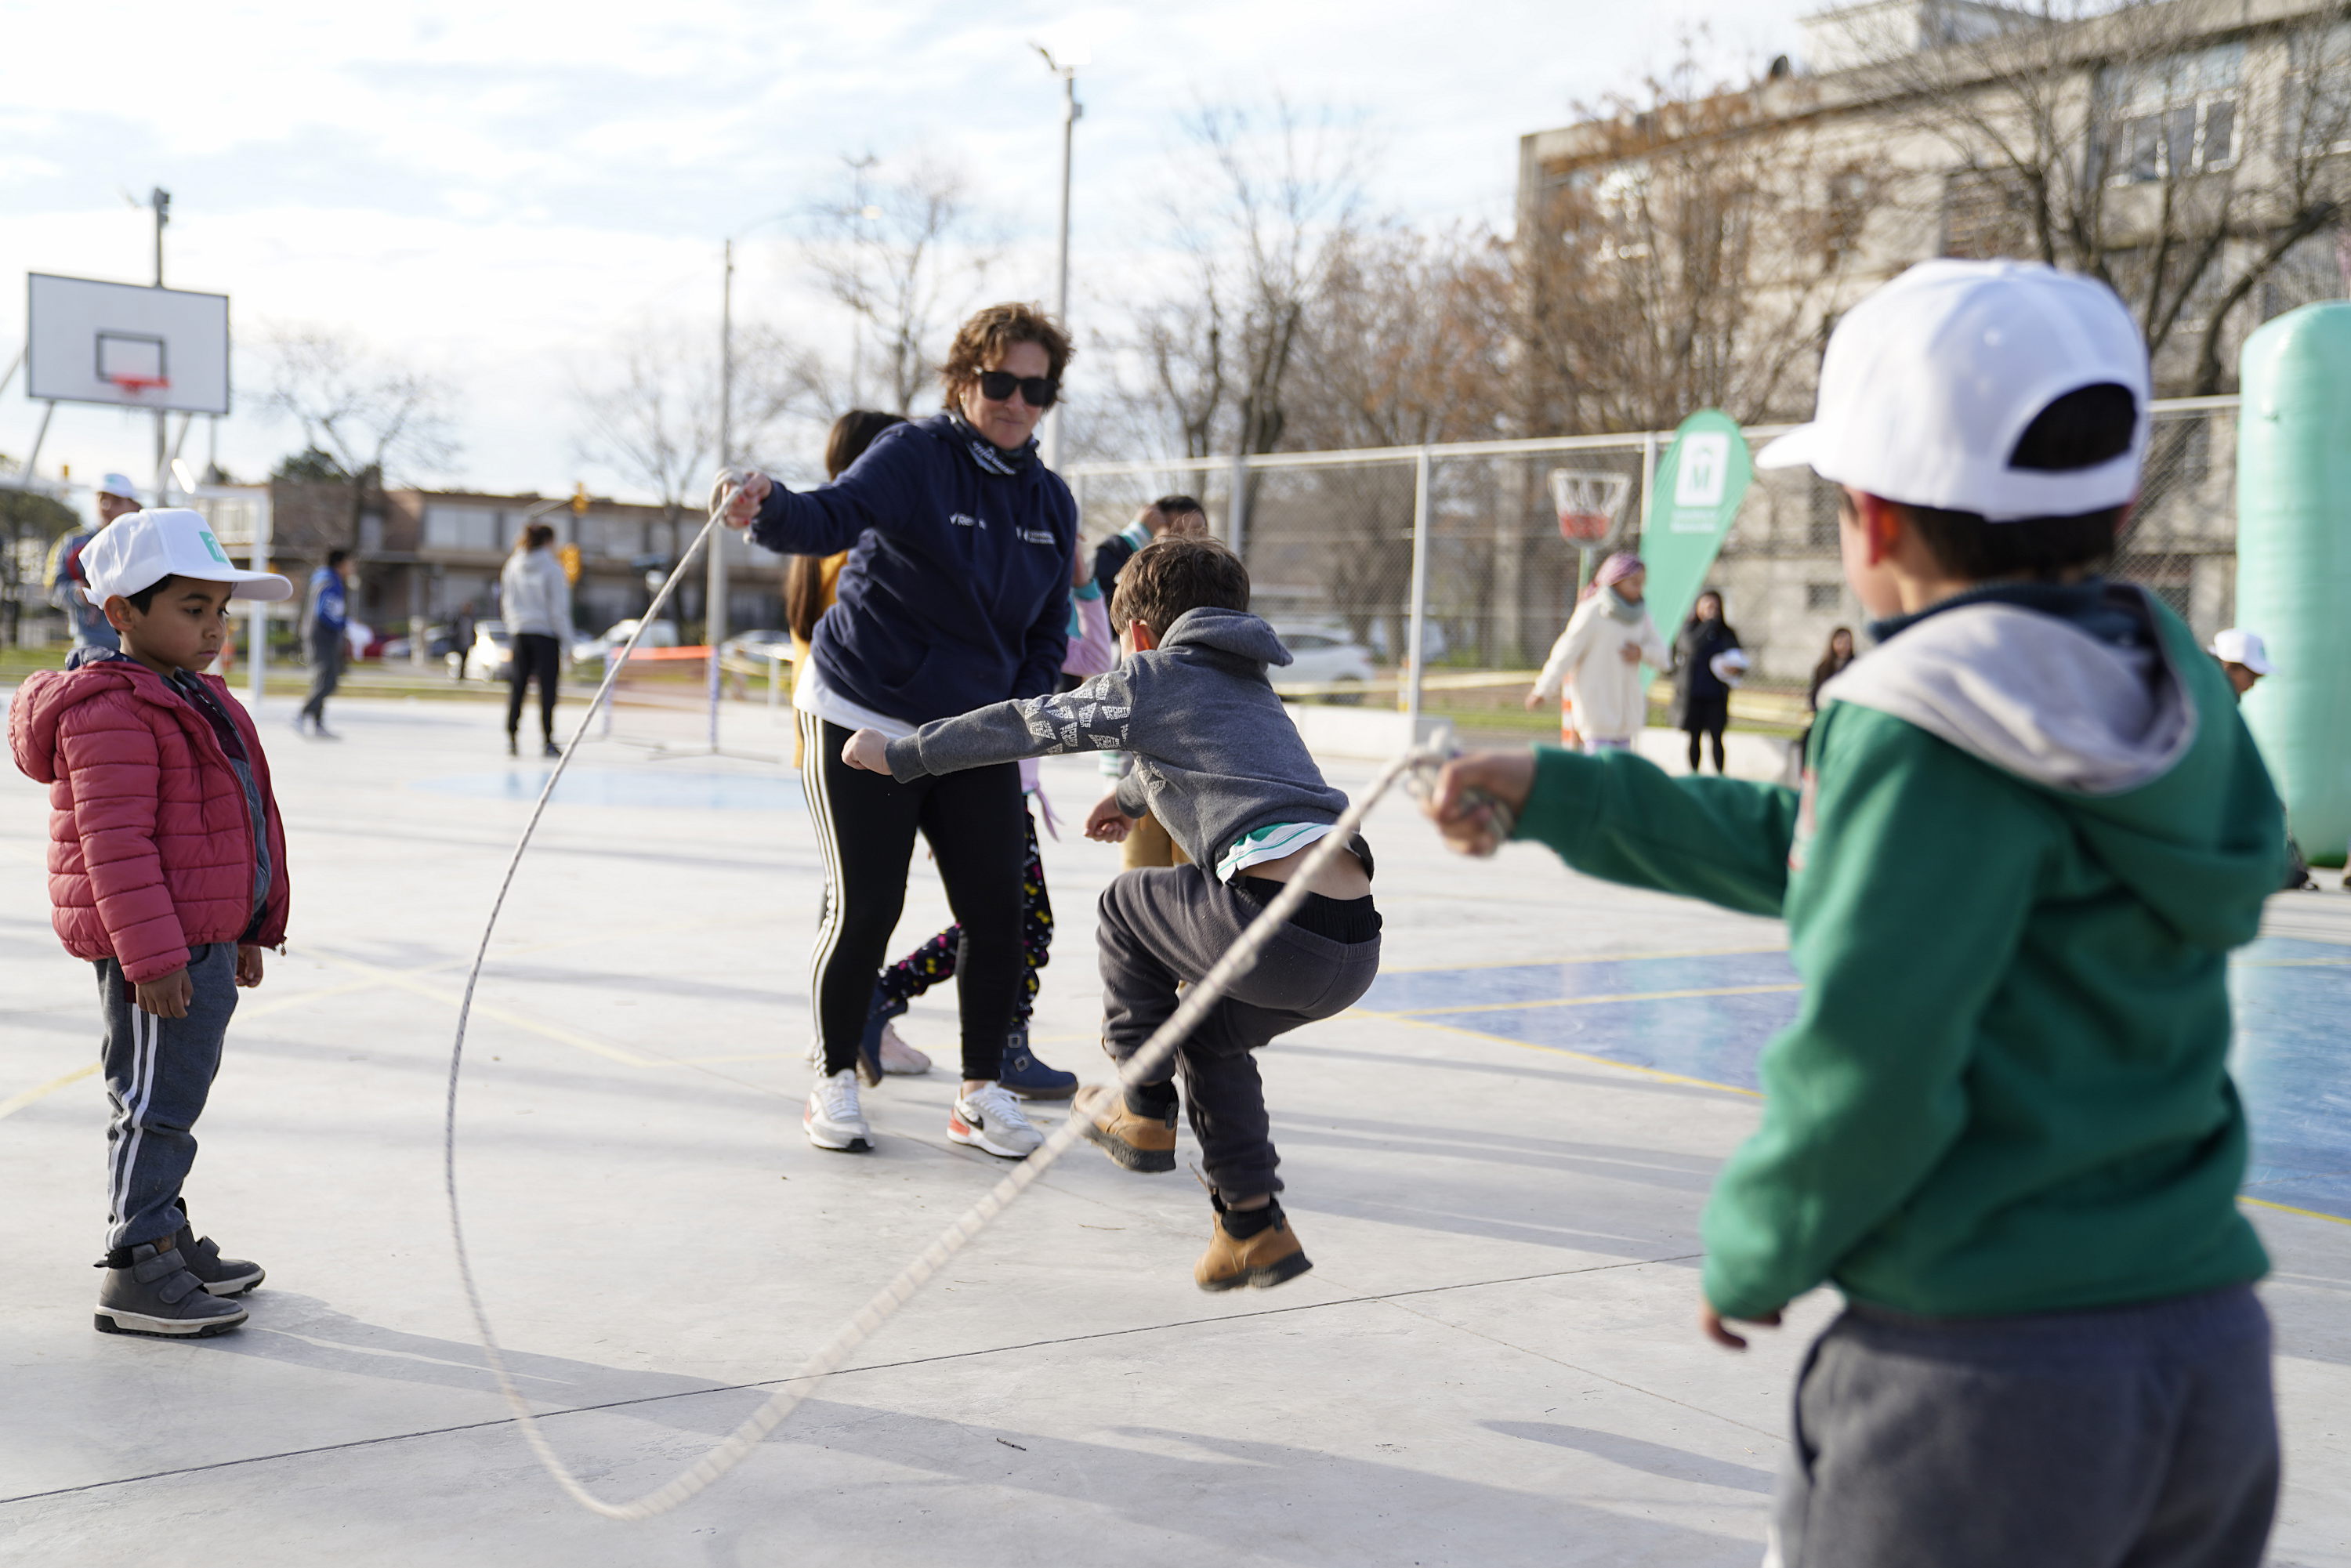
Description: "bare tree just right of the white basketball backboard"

(263, 327), (458, 550)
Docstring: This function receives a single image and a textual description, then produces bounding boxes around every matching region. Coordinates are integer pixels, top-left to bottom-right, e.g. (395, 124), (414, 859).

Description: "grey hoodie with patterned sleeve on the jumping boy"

(889, 609), (1347, 867)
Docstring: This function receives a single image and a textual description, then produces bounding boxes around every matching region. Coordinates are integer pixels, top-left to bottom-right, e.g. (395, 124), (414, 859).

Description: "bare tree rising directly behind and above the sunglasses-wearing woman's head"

(802, 153), (994, 411)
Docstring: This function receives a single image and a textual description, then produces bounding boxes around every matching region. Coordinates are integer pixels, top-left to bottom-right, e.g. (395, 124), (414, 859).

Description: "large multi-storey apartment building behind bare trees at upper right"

(1516, 0), (2351, 679)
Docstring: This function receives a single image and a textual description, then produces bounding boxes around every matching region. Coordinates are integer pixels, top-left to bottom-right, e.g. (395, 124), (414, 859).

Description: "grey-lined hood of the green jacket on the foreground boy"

(1820, 583), (2283, 947)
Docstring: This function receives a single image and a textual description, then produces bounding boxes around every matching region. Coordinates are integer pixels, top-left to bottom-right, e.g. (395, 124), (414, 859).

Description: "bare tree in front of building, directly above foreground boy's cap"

(1881, 0), (2351, 395)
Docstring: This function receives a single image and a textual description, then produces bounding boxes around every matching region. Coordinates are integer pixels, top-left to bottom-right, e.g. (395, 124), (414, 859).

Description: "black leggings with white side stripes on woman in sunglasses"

(799, 712), (1027, 1079)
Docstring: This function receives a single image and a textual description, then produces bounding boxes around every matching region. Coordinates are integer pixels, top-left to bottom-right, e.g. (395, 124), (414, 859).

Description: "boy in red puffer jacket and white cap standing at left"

(7, 508), (294, 1338)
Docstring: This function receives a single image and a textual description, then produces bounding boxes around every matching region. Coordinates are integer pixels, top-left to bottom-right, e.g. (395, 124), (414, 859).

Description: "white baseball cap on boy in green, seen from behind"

(1756, 261), (2154, 522)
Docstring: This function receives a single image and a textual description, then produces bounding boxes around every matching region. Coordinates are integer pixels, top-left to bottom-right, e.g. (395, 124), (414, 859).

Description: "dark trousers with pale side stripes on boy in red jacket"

(94, 943), (237, 1248)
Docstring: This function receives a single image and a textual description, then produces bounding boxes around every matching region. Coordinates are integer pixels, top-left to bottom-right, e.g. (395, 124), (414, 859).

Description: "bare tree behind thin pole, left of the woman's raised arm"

(571, 320), (825, 559)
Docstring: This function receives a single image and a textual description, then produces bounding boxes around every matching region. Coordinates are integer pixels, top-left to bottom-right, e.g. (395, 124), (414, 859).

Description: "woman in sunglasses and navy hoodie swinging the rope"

(719, 306), (1077, 1159)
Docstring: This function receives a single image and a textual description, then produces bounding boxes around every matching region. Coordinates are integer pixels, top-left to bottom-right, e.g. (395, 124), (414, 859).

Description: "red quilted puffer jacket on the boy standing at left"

(7, 658), (289, 983)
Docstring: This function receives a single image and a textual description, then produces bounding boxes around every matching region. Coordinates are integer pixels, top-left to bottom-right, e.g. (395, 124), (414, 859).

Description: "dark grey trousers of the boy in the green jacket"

(1773, 1286), (2278, 1568)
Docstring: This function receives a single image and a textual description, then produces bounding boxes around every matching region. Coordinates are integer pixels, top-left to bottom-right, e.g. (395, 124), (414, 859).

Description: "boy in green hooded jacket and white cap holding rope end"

(1429, 261), (2285, 1568)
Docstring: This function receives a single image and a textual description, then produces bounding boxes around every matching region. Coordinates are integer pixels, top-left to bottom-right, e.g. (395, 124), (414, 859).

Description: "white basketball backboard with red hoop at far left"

(24, 273), (228, 414)
